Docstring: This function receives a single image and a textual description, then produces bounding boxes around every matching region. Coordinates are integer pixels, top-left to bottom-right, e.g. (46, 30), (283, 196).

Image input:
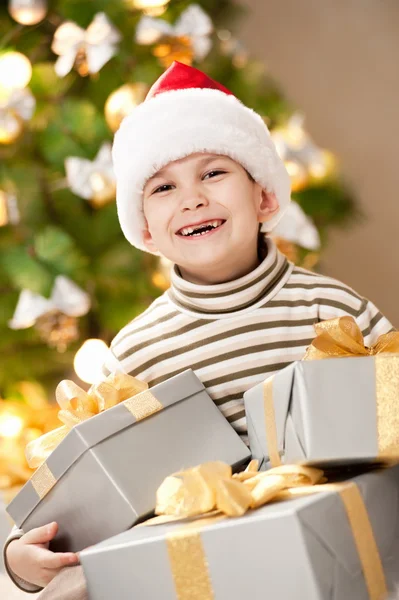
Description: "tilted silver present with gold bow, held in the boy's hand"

(7, 370), (250, 552)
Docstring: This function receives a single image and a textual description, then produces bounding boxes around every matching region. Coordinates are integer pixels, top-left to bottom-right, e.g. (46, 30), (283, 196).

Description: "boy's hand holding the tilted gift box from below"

(6, 523), (79, 587)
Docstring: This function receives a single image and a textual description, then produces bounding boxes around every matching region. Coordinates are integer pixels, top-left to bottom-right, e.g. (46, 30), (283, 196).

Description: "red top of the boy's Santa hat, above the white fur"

(146, 61), (234, 100)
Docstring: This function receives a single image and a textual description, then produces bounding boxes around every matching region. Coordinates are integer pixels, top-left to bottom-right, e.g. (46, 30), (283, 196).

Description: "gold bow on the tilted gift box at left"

(25, 373), (148, 469)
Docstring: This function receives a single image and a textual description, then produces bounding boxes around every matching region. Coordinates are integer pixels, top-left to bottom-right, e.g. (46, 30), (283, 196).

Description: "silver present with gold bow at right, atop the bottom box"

(244, 317), (399, 468)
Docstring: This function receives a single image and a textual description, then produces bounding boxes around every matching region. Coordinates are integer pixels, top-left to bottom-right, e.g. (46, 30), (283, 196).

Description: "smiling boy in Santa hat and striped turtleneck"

(3, 63), (392, 591)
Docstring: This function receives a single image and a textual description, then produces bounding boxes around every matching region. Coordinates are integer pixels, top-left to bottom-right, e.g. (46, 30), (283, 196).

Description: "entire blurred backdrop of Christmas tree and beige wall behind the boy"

(0, 0), (399, 588)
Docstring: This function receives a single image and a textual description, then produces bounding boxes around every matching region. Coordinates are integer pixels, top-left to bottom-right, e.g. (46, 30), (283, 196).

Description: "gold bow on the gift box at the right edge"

(303, 317), (399, 360)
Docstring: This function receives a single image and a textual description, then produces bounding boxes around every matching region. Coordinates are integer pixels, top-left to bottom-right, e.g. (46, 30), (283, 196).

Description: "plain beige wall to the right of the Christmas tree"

(238, 0), (399, 328)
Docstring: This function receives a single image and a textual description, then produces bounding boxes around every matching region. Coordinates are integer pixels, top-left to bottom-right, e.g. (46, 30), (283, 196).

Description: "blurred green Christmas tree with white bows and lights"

(0, 0), (355, 398)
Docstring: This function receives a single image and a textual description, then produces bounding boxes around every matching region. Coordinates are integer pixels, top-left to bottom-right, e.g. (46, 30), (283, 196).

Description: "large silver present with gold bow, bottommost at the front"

(80, 465), (399, 600)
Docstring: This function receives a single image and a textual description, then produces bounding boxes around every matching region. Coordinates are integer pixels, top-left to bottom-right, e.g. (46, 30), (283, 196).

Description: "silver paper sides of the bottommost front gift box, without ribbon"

(80, 467), (399, 600)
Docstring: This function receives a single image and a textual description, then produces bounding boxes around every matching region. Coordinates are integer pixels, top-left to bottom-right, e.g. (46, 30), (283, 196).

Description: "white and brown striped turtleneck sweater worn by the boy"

(104, 239), (393, 441)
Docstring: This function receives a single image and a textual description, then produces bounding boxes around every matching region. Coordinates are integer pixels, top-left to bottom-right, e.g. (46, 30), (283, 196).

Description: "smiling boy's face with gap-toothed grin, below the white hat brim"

(143, 153), (278, 283)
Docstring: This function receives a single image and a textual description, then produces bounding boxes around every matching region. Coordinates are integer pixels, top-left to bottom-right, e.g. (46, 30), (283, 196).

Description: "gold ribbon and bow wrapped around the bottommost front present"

(152, 461), (387, 600)
